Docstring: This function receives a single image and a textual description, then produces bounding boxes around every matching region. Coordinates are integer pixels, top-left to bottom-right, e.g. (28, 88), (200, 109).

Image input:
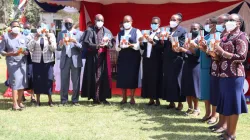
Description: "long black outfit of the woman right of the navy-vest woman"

(141, 34), (163, 99)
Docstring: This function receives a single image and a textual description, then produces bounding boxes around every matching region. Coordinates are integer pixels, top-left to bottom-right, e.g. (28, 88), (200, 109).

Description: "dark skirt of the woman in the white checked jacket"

(33, 59), (53, 95)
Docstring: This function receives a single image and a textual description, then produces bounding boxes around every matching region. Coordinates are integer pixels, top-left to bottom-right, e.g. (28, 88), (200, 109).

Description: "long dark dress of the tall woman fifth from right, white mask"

(162, 26), (186, 102)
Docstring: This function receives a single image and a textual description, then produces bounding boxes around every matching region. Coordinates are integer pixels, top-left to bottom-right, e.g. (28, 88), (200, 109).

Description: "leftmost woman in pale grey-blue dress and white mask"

(0, 21), (28, 110)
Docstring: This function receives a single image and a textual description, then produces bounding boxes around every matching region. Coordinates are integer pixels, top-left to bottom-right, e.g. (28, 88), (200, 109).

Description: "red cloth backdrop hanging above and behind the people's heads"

(80, 1), (239, 35)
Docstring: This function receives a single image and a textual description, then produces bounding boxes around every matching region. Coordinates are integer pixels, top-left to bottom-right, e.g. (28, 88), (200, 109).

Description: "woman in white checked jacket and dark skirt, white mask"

(28, 23), (56, 106)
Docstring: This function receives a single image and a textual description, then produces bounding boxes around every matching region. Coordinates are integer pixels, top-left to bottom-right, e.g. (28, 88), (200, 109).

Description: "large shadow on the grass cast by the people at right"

(108, 98), (217, 140)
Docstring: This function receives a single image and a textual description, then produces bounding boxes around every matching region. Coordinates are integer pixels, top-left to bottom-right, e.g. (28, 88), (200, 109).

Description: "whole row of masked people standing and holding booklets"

(0, 13), (248, 140)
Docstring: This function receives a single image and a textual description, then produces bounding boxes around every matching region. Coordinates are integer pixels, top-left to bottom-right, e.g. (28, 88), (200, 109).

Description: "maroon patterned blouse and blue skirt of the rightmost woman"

(217, 30), (248, 116)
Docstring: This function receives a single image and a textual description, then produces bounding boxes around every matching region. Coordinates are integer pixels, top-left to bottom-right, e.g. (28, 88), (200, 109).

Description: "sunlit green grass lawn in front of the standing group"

(0, 58), (250, 140)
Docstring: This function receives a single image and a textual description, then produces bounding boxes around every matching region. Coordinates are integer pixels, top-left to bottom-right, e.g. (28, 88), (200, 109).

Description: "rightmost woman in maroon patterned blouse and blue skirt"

(215, 14), (248, 140)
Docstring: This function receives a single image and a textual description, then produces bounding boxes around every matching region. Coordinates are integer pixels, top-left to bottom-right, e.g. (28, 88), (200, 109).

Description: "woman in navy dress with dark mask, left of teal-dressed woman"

(179, 23), (203, 116)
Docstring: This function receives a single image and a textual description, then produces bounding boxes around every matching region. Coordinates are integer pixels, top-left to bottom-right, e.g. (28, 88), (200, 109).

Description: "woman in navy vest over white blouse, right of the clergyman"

(116, 15), (142, 104)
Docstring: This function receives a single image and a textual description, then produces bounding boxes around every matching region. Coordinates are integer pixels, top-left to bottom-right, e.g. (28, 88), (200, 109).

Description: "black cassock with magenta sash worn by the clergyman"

(81, 27), (113, 101)
